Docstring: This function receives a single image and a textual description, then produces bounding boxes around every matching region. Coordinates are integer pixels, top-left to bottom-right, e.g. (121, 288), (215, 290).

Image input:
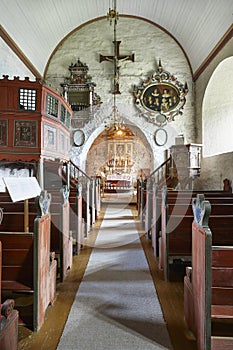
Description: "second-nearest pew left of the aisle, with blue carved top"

(50, 186), (73, 282)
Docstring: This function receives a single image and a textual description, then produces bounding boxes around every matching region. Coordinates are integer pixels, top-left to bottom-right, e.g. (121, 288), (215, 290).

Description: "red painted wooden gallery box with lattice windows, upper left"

(0, 76), (72, 162)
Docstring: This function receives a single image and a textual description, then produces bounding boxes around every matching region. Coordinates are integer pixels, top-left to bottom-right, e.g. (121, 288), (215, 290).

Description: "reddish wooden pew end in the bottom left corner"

(0, 241), (19, 350)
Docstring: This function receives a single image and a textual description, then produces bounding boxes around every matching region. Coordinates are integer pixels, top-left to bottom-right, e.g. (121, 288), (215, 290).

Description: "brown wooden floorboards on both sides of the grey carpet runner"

(16, 205), (197, 350)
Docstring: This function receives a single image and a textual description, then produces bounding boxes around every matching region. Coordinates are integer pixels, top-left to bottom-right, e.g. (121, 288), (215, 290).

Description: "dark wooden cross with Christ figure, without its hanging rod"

(100, 40), (134, 94)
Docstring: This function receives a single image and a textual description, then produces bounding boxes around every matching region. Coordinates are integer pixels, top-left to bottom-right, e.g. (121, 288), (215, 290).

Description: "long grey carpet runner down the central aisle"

(57, 206), (172, 350)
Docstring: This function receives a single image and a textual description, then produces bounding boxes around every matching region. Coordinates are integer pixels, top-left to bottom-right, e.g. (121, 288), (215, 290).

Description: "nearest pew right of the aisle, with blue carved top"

(192, 201), (233, 350)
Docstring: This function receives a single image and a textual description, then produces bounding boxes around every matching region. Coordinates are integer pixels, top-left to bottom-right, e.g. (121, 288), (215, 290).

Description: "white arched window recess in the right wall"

(202, 57), (233, 157)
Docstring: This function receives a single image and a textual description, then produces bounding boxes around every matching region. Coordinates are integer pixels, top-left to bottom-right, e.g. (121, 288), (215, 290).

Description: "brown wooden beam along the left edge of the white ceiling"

(0, 25), (42, 79)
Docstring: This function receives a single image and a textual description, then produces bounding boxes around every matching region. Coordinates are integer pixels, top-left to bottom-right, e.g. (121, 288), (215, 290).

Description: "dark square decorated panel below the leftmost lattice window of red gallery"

(14, 120), (37, 147)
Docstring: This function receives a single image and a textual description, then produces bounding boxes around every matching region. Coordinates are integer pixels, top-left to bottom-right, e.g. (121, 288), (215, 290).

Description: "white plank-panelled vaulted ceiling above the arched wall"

(0, 0), (233, 76)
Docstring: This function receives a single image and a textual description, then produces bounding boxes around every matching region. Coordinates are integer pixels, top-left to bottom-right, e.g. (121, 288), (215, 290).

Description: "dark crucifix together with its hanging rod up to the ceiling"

(100, 0), (134, 94)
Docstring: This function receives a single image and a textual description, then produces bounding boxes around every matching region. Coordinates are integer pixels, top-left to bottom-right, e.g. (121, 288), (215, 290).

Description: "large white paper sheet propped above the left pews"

(3, 176), (41, 202)
